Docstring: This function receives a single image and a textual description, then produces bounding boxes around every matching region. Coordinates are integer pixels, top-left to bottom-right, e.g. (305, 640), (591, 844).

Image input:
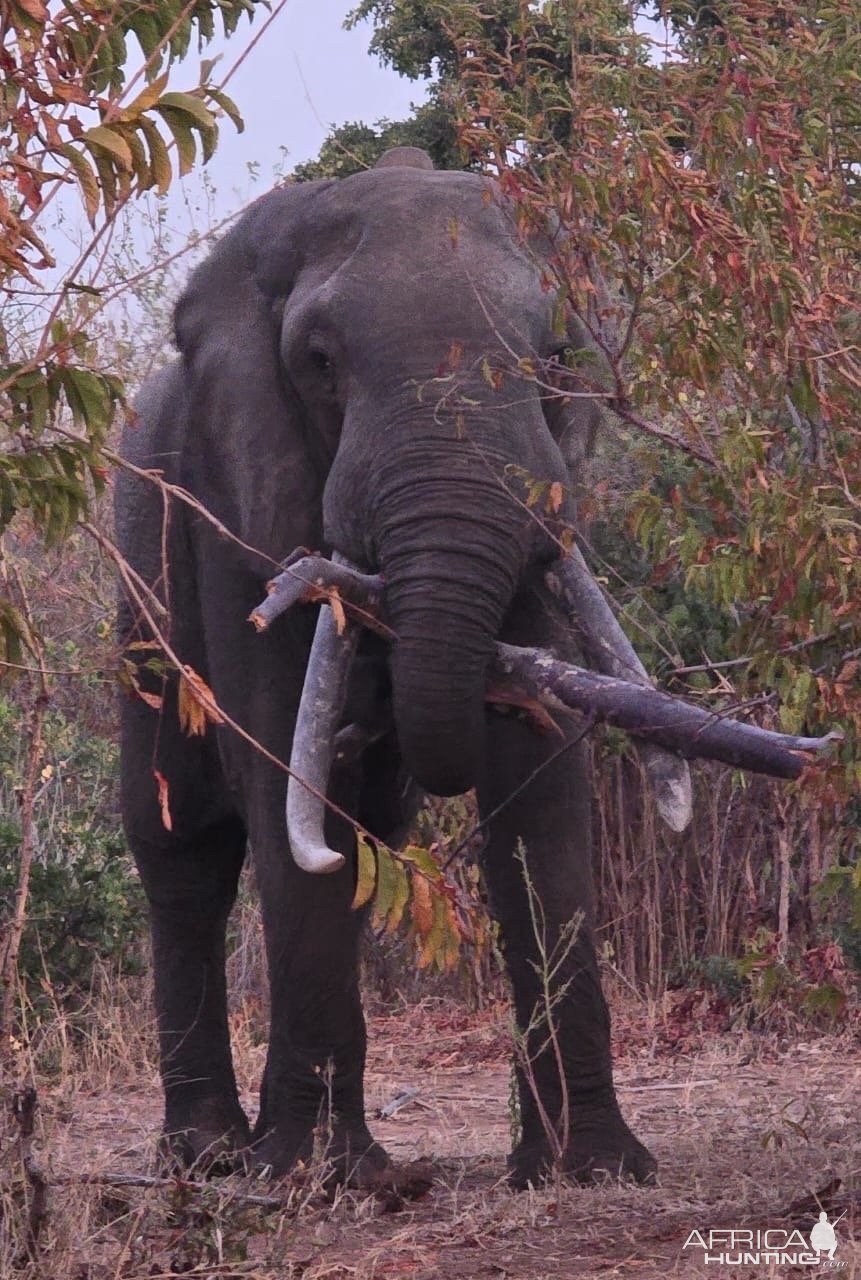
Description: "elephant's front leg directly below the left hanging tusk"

(245, 785), (389, 1187)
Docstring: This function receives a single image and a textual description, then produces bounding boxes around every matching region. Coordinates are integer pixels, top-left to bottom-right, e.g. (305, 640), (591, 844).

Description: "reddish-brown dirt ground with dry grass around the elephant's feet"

(13, 1006), (861, 1280)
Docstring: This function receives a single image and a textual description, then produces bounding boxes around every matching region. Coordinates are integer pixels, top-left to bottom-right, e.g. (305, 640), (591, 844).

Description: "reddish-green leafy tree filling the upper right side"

(353, 0), (861, 977)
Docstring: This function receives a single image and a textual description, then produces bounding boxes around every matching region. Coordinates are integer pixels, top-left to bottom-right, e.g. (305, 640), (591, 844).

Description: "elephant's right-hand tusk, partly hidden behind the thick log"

(545, 545), (693, 831)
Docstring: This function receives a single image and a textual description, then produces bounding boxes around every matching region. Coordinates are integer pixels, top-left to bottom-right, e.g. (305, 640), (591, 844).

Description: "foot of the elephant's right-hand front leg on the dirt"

(508, 1114), (658, 1190)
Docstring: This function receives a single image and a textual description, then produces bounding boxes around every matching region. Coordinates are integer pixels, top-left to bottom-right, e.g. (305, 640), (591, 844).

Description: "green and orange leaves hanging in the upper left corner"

(0, 0), (255, 662)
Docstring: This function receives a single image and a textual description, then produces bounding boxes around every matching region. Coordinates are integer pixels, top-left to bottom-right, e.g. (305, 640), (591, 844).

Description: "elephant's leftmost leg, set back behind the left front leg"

(130, 817), (248, 1166)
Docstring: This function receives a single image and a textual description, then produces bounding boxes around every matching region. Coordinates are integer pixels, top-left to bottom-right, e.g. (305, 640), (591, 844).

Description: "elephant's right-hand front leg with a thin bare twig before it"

(478, 716), (656, 1187)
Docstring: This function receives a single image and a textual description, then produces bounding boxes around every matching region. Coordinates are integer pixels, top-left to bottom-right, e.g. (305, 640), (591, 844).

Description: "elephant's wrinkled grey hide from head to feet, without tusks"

(118, 151), (654, 1185)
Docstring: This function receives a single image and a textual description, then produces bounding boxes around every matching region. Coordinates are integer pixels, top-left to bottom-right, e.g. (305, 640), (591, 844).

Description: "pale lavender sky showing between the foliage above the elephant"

(35, 0), (664, 337)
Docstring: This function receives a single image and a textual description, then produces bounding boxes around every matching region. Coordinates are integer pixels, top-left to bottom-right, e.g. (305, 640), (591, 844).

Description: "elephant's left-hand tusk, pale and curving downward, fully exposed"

(284, 553), (359, 876)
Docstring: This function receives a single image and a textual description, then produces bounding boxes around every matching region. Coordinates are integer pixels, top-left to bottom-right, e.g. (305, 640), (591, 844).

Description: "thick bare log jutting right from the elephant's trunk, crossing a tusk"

(494, 644), (839, 778)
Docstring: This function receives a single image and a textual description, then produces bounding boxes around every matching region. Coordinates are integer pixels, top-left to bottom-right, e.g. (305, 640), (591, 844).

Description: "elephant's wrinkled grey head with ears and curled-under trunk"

(177, 148), (685, 824)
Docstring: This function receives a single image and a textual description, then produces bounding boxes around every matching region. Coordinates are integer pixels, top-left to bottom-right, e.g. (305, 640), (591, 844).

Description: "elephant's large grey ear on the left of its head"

(174, 182), (331, 572)
